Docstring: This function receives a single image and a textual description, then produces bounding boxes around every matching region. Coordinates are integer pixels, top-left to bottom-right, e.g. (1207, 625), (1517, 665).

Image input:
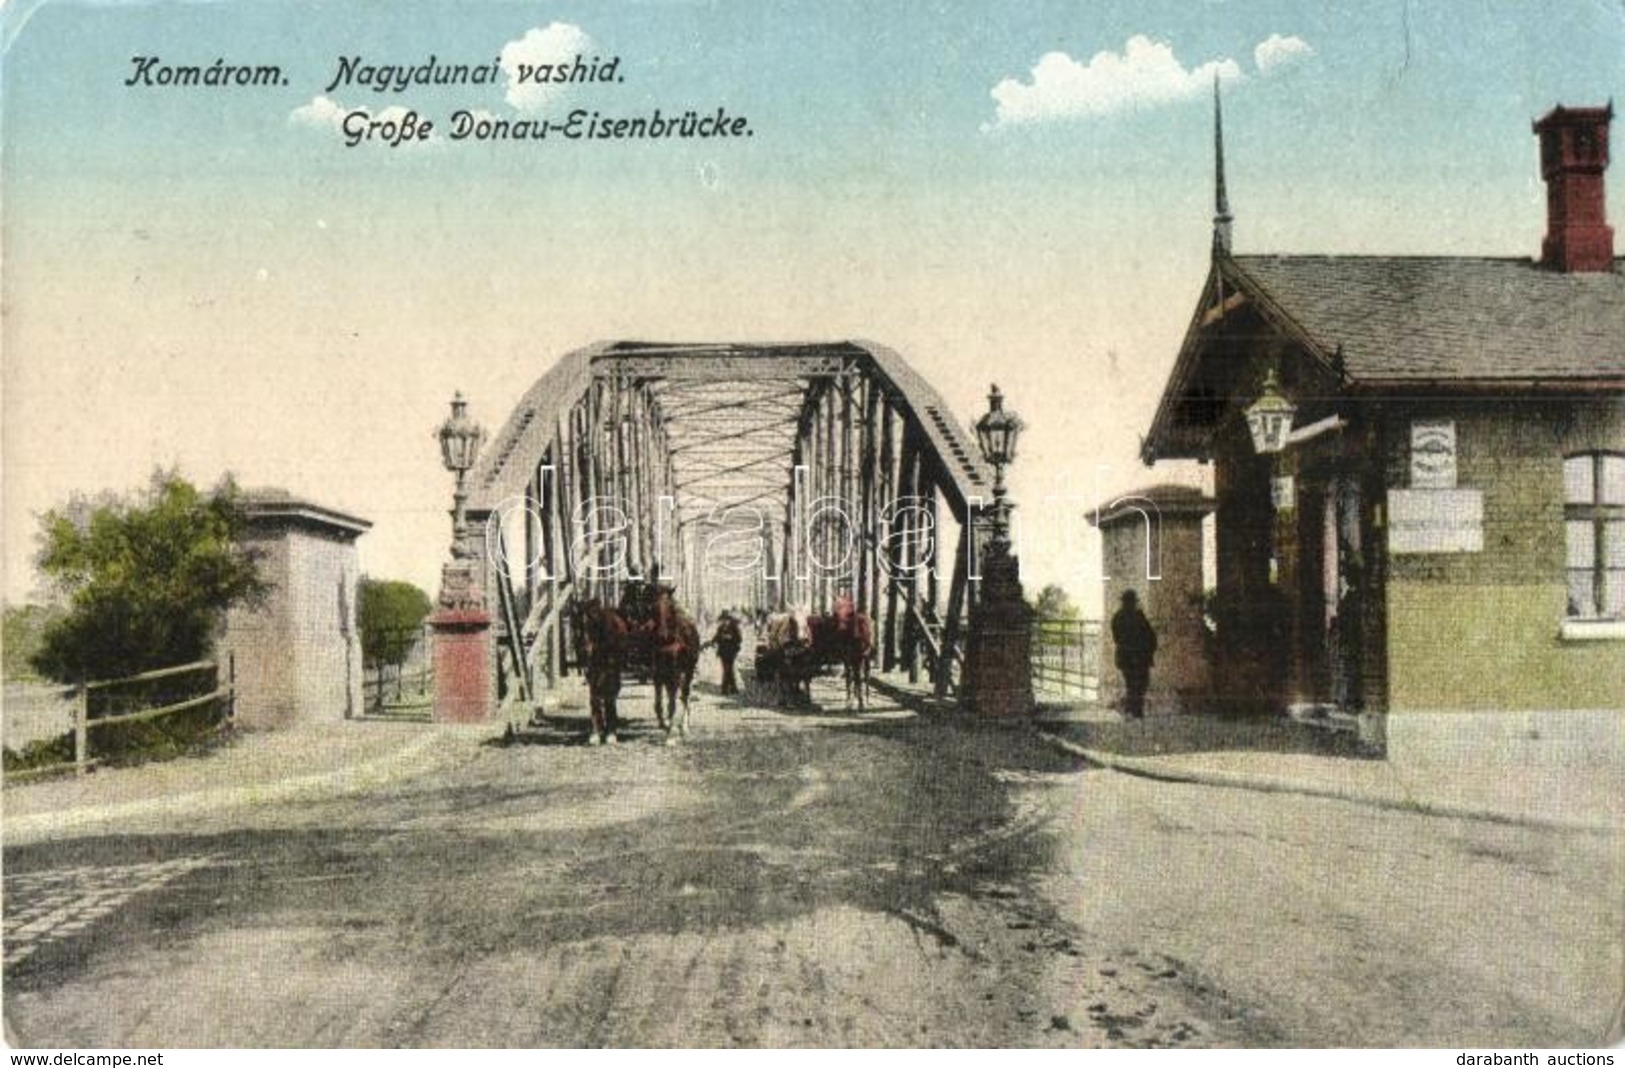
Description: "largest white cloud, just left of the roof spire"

(993, 34), (1243, 127)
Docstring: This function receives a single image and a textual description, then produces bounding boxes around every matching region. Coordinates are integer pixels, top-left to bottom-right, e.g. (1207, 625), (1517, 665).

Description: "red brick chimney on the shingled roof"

(1534, 101), (1614, 271)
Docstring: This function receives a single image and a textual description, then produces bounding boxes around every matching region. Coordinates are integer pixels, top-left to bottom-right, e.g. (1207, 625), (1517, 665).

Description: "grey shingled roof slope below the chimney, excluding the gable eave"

(1222, 255), (1625, 384)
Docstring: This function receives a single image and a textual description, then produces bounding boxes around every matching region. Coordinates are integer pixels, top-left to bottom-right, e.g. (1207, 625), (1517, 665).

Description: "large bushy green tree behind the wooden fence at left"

(31, 470), (267, 683)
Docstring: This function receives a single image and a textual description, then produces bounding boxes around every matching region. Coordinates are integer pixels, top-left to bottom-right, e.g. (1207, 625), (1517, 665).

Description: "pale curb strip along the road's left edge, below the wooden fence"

(0, 732), (471, 845)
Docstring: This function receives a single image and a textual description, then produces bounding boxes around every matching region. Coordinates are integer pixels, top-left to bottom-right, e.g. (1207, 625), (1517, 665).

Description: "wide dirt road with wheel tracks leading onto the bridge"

(5, 679), (1619, 1047)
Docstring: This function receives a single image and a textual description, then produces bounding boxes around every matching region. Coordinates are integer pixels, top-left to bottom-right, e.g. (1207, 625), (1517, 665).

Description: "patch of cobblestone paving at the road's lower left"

(5, 855), (216, 969)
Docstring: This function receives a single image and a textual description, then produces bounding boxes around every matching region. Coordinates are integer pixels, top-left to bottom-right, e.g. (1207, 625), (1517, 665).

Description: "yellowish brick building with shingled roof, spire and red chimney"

(1142, 106), (1625, 759)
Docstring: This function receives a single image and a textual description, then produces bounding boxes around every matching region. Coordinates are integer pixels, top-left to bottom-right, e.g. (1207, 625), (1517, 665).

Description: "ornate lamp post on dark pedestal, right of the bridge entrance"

(965, 385), (1034, 715)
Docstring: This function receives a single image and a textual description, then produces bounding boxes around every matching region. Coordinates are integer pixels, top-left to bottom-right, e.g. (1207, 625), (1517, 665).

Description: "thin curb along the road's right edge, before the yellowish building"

(1038, 730), (1620, 834)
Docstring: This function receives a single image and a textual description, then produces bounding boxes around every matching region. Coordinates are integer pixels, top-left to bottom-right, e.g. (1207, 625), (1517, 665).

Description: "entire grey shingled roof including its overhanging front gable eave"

(1141, 252), (1625, 463)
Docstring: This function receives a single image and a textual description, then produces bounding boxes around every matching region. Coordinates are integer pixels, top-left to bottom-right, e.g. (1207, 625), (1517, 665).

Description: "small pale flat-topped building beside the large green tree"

(219, 489), (372, 728)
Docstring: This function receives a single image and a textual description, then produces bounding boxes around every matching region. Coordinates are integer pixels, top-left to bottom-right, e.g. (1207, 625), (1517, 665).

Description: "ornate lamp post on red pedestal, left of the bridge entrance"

(429, 393), (496, 723)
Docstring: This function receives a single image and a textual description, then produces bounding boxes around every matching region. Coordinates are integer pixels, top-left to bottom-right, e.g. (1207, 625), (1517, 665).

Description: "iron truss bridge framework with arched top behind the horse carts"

(468, 341), (993, 701)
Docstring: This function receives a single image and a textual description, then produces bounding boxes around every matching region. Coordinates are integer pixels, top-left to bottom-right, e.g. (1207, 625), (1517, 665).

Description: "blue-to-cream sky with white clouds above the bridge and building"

(0, 0), (1625, 611)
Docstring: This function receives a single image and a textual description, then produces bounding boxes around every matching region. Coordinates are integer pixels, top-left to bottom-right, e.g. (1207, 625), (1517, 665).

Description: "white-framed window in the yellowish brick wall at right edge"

(1563, 452), (1625, 619)
